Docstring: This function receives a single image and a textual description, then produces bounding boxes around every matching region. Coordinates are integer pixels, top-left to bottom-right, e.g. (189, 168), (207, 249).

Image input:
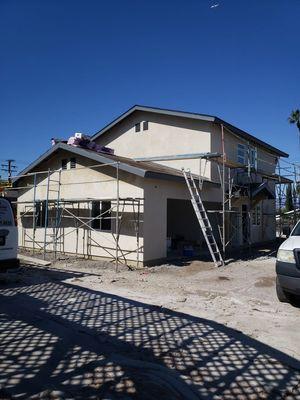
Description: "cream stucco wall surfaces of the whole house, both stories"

(18, 111), (282, 262)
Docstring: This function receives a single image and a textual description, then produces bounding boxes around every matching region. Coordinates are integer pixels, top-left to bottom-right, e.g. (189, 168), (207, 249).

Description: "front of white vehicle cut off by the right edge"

(276, 221), (300, 303)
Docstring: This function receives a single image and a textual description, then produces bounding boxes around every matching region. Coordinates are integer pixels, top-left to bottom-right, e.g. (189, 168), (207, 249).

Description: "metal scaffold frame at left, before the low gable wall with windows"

(9, 161), (144, 271)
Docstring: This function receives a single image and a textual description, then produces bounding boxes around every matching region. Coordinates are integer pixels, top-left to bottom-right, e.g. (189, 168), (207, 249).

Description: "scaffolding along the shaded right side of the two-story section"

(136, 124), (292, 261)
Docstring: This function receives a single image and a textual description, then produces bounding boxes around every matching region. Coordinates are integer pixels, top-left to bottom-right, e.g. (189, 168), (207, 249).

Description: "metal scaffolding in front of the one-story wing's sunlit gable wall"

(9, 161), (144, 271)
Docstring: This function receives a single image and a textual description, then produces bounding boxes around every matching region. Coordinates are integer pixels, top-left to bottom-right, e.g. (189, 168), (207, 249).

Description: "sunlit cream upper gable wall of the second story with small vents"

(96, 112), (212, 179)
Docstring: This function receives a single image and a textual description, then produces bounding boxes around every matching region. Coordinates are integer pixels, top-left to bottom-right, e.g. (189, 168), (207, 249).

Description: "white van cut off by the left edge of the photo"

(0, 197), (18, 267)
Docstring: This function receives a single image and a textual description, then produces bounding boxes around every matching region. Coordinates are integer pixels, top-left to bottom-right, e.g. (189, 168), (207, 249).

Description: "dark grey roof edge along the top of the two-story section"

(92, 105), (289, 157)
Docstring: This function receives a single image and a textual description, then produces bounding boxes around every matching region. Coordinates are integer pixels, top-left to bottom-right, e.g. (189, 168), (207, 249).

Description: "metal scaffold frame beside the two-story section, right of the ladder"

(142, 124), (292, 261)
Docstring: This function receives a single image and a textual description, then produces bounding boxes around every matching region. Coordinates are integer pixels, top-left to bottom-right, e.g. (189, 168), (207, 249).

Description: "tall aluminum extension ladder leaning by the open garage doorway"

(182, 168), (224, 267)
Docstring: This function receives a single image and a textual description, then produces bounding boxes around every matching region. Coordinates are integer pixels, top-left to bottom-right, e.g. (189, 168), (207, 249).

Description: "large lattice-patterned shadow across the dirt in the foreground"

(0, 269), (300, 400)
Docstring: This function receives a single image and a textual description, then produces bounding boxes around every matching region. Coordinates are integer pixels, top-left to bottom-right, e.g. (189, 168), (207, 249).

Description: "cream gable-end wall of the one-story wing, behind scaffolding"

(18, 151), (144, 261)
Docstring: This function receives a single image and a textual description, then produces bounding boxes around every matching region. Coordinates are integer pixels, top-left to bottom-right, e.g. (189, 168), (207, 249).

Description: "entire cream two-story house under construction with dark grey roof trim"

(15, 106), (288, 264)
